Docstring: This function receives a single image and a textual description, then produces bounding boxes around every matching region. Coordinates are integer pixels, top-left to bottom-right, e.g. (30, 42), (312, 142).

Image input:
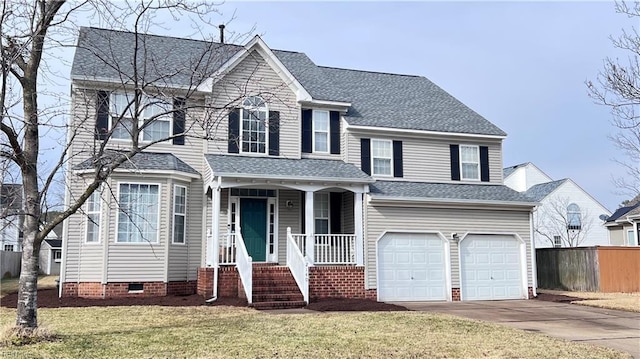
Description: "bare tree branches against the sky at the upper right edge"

(587, 1), (640, 197)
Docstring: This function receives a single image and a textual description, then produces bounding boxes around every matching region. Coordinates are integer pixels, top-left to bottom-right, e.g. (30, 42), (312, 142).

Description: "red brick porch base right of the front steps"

(309, 266), (378, 300)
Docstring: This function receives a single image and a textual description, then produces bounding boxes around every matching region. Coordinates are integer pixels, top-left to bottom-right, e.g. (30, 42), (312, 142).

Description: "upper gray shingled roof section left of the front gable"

(71, 27), (243, 86)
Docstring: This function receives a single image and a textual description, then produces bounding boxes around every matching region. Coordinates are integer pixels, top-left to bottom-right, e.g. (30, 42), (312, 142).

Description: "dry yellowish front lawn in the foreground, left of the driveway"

(0, 306), (629, 358)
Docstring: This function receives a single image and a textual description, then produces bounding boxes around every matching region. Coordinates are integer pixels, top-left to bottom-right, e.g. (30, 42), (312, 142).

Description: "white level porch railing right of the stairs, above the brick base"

(291, 234), (356, 264)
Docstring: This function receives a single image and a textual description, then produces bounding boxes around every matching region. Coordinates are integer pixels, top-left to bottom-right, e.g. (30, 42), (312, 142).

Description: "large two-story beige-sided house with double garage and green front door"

(61, 28), (536, 307)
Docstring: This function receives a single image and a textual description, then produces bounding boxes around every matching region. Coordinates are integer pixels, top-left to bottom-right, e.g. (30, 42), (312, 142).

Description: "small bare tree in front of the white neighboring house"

(534, 197), (593, 247)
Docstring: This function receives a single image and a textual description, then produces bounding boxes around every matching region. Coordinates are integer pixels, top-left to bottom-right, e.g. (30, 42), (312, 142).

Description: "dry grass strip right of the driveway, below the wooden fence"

(538, 289), (640, 313)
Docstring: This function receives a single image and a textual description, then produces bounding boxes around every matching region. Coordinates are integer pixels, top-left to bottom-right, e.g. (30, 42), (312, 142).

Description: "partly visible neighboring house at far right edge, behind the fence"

(604, 200), (640, 246)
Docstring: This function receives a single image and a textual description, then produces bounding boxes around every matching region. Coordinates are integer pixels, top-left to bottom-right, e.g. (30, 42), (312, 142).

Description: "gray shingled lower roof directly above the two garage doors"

(369, 181), (535, 206)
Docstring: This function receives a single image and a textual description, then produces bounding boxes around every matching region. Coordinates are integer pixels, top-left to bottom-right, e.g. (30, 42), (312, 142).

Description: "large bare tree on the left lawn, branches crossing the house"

(0, 0), (292, 332)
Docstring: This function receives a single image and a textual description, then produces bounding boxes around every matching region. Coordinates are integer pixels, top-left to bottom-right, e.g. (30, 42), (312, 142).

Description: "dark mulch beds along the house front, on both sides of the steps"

(0, 288), (408, 312)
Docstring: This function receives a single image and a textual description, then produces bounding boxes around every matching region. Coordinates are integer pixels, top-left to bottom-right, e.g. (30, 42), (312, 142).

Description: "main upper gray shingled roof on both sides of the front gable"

(71, 27), (506, 136)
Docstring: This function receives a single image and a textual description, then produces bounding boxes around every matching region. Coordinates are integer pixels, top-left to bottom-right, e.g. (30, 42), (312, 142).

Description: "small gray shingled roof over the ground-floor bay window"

(74, 151), (199, 174)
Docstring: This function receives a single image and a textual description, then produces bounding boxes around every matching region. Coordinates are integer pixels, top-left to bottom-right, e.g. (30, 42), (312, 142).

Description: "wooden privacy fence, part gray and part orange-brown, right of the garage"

(536, 246), (640, 293)
